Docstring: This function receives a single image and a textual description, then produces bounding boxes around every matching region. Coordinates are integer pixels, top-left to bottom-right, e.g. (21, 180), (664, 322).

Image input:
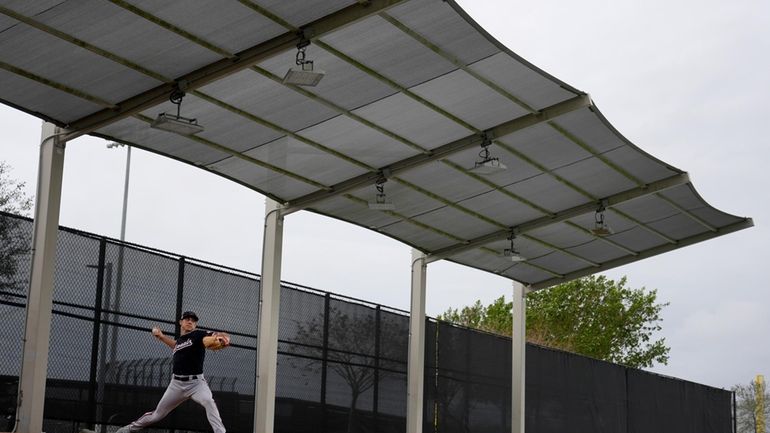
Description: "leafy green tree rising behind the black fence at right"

(438, 275), (670, 368)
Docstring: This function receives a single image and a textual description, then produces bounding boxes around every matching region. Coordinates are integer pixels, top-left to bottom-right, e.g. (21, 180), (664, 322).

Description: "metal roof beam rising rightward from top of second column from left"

(286, 95), (591, 210)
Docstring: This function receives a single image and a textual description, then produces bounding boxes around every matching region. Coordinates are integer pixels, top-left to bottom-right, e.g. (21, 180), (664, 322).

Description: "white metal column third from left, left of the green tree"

(406, 250), (427, 433)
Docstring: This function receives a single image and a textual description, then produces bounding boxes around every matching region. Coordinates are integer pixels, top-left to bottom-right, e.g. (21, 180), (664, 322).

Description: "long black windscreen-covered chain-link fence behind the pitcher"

(0, 213), (733, 433)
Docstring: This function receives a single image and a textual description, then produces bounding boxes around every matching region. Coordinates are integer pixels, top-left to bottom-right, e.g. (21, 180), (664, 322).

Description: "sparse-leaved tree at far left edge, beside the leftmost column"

(0, 161), (32, 298)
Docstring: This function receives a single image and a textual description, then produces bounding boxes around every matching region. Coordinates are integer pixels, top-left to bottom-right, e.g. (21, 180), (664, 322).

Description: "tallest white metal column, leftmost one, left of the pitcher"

(15, 123), (64, 433)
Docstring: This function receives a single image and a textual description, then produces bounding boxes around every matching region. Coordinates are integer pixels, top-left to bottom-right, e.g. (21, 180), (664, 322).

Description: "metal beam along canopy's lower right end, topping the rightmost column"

(532, 218), (754, 290)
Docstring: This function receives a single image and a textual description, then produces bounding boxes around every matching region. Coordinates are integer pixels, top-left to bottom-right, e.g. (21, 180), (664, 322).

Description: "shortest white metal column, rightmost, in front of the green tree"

(511, 281), (527, 433)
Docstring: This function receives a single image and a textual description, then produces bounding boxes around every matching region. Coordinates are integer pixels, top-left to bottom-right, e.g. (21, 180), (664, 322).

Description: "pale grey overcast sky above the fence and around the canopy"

(0, 0), (770, 388)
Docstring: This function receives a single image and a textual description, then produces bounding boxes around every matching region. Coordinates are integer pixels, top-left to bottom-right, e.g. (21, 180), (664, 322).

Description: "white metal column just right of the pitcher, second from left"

(254, 199), (283, 433)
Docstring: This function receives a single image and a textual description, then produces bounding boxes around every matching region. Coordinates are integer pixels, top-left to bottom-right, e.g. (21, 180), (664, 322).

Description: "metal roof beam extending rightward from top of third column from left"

(428, 173), (690, 269)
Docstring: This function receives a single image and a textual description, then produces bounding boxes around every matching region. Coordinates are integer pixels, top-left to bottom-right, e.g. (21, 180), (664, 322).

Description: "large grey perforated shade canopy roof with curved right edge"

(0, 0), (752, 288)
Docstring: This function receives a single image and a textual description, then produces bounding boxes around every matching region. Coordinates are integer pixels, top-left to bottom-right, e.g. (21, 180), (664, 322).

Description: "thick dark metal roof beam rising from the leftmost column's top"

(60, 0), (403, 140)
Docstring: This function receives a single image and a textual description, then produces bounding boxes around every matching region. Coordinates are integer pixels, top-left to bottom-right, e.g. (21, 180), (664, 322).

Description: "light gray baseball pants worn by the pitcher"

(129, 375), (225, 433)
